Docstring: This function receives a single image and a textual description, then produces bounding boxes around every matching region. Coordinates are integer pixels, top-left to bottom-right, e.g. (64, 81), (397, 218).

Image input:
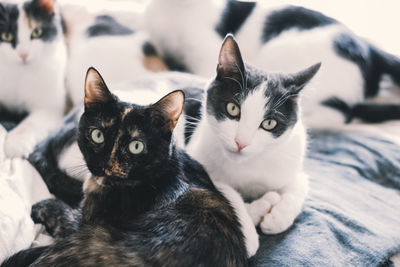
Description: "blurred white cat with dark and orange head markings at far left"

(0, 0), (67, 157)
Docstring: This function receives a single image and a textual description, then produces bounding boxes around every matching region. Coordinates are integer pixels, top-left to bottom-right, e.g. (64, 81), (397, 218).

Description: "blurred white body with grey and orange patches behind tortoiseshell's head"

(63, 7), (168, 105)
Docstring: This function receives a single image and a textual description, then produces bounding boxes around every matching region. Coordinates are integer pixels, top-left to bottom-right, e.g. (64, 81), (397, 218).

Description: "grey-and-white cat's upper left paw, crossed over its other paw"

(246, 191), (281, 225)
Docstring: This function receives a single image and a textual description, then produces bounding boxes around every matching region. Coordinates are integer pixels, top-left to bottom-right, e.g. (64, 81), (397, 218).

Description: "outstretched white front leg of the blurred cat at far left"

(4, 110), (62, 158)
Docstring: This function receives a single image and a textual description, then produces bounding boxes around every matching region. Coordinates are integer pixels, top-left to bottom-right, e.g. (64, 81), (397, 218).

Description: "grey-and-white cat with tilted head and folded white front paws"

(187, 35), (321, 234)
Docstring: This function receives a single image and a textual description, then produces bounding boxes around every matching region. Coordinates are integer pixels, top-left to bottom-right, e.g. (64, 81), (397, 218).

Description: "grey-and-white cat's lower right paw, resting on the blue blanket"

(260, 204), (295, 234)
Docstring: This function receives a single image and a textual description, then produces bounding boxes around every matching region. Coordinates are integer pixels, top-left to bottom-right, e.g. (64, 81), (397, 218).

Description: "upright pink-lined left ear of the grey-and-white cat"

(217, 34), (245, 78)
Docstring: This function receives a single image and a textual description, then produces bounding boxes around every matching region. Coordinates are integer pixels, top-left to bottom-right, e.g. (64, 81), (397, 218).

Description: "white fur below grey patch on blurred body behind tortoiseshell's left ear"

(67, 22), (155, 105)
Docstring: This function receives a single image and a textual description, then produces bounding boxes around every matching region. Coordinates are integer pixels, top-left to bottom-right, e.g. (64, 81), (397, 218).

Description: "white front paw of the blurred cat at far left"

(4, 131), (35, 158)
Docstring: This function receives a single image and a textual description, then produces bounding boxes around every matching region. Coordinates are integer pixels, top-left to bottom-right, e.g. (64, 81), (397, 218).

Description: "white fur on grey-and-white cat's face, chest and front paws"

(187, 85), (308, 233)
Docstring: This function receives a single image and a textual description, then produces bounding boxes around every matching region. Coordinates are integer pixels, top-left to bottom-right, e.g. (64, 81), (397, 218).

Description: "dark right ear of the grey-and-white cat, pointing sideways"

(284, 62), (321, 96)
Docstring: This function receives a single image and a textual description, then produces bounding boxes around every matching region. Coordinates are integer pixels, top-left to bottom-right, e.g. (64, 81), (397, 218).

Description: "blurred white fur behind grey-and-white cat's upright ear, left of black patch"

(143, 0), (222, 78)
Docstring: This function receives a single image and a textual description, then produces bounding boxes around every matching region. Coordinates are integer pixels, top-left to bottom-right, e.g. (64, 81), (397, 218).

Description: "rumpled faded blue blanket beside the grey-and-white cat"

(252, 131), (400, 266)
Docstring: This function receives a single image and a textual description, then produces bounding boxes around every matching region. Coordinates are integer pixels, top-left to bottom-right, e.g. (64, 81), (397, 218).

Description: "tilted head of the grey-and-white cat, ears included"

(206, 35), (321, 159)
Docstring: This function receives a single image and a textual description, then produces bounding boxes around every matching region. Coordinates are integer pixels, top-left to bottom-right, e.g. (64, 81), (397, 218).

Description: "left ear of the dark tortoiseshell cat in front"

(84, 67), (115, 108)
